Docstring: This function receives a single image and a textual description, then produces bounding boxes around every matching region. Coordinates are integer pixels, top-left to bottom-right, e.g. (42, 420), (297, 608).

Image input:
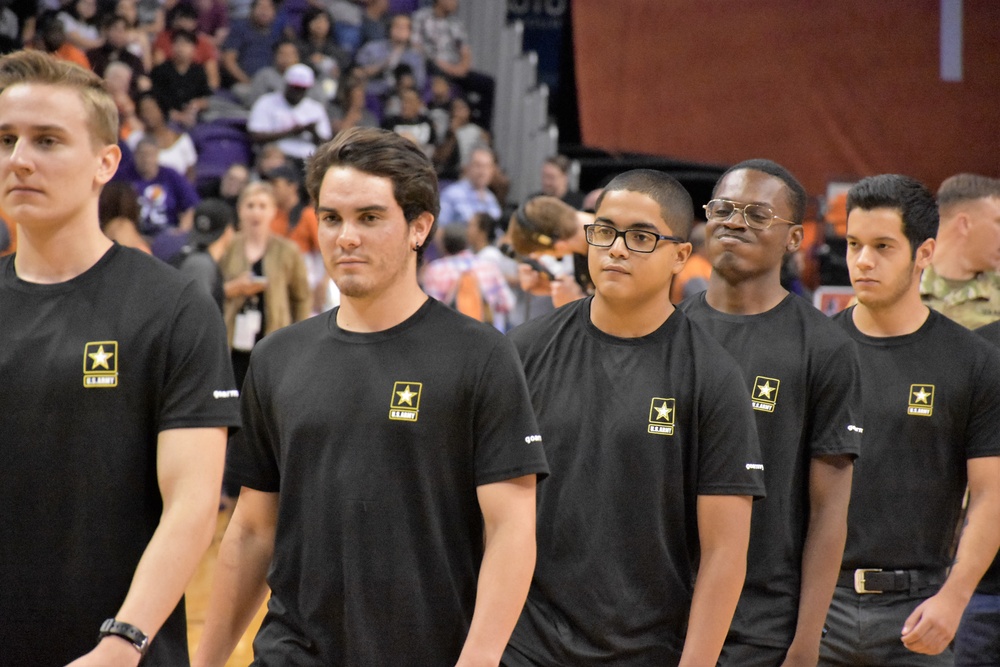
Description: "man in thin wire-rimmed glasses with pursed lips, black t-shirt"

(681, 160), (862, 667)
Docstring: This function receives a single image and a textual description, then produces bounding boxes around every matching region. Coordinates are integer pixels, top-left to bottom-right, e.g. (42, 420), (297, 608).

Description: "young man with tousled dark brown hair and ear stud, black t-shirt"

(195, 128), (547, 667)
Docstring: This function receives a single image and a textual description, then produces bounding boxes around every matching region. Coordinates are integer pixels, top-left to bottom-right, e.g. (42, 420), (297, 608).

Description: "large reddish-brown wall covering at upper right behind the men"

(573, 0), (1000, 194)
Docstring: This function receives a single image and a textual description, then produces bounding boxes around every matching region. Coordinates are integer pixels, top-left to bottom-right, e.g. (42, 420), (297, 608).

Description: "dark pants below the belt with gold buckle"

(819, 586), (955, 667)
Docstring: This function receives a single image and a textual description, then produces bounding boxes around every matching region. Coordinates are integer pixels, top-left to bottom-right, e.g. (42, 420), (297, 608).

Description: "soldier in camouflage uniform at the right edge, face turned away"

(920, 174), (1000, 329)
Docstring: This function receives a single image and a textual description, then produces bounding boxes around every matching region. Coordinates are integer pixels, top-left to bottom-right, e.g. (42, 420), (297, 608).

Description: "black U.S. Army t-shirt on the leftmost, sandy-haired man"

(0, 245), (239, 667)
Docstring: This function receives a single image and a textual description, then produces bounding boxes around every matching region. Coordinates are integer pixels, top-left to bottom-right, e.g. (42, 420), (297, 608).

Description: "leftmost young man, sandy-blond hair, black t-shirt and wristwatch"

(0, 51), (239, 667)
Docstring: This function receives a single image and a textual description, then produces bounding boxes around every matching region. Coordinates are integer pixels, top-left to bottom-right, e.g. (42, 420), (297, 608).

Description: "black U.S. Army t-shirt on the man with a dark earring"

(227, 299), (547, 667)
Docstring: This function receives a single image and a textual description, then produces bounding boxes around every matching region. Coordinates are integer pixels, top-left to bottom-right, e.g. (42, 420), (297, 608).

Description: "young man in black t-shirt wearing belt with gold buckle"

(820, 175), (1000, 666)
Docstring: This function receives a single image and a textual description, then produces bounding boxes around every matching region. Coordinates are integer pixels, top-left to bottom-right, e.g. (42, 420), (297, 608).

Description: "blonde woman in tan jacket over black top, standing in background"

(219, 183), (310, 387)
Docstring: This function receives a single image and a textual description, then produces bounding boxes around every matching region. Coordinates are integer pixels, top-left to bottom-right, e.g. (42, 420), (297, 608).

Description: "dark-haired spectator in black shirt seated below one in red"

(149, 30), (212, 127)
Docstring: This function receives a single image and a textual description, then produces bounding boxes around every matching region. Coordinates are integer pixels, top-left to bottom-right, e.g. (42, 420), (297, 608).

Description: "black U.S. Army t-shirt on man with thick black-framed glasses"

(509, 298), (764, 665)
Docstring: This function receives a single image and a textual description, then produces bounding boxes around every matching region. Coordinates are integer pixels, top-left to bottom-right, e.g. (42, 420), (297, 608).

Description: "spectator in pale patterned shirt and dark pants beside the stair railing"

(413, 0), (495, 130)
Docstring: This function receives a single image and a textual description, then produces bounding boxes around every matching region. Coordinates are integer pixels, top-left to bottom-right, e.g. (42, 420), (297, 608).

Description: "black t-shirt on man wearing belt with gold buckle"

(834, 307), (1000, 569)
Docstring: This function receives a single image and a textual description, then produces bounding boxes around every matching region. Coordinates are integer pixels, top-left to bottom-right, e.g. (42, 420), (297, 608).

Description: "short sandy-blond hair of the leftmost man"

(0, 51), (118, 147)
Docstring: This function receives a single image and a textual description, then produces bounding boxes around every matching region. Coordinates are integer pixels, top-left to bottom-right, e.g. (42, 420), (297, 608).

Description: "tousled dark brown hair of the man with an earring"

(306, 127), (440, 261)
